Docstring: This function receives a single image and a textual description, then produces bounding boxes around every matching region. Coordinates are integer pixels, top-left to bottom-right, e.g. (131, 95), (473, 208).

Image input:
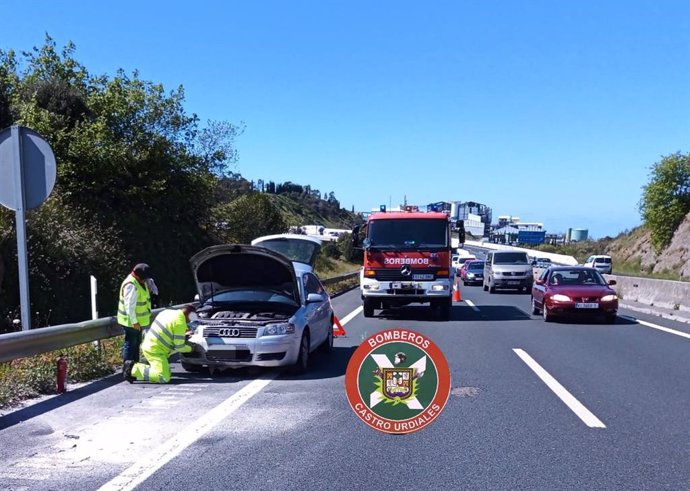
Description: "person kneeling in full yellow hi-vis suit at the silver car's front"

(124, 304), (195, 384)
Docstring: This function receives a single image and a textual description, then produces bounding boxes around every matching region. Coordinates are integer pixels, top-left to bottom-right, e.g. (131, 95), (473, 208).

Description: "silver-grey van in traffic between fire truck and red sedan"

(482, 250), (534, 293)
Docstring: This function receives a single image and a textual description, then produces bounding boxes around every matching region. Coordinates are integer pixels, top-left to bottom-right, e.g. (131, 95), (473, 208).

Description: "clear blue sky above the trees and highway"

(0, 0), (690, 237)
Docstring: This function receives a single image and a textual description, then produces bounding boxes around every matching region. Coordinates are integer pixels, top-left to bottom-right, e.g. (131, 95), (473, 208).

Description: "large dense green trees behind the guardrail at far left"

(0, 37), (243, 323)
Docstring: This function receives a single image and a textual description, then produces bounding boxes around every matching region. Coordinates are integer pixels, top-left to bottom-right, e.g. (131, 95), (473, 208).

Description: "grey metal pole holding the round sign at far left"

(11, 126), (31, 331)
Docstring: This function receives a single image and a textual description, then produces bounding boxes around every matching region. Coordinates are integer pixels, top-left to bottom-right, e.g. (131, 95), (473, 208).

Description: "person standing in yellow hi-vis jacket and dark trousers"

(117, 263), (151, 373)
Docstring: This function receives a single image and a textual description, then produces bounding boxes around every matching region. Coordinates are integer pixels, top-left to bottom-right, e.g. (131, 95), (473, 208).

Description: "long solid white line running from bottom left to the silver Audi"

(99, 371), (279, 491)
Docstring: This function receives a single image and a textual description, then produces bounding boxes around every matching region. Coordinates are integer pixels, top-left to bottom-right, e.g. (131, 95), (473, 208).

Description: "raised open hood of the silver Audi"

(189, 244), (300, 305)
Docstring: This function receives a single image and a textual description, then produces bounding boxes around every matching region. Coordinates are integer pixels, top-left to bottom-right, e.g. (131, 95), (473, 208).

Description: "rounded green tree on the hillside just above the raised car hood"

(214, 193), (287, 244)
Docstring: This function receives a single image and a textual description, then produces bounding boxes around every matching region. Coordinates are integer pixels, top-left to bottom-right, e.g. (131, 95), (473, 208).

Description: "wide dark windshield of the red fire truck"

(368, 218), (448, 249)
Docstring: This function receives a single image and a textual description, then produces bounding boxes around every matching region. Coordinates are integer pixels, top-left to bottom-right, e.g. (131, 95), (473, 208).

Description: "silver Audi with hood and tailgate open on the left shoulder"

(181, 235), (333, 372)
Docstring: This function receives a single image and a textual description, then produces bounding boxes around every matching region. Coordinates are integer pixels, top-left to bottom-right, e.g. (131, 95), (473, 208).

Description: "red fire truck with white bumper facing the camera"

(352, 207), (454, 319)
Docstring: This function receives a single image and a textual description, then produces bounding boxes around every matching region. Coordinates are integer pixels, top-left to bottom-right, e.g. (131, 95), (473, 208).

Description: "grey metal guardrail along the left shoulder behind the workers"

(0, 271), (359, 362)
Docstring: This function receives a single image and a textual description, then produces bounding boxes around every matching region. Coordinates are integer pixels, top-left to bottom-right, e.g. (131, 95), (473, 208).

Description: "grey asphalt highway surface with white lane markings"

(0, 278), (690, 490)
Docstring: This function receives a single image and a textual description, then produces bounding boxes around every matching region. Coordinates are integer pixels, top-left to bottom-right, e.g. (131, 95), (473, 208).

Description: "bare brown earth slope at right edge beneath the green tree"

(606, 213), (690, 281)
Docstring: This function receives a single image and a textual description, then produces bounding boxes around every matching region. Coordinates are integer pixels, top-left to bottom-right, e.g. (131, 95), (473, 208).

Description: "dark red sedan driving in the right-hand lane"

(532, 266), (618, 324)
